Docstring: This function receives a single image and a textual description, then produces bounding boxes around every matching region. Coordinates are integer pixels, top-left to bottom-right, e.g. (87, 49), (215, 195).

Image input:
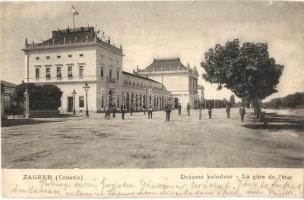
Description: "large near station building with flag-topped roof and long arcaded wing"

(23, 27), (169, 112)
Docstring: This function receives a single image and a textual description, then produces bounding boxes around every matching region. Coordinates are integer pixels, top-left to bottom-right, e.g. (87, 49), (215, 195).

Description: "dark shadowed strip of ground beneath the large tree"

(243, 113), (304, 133)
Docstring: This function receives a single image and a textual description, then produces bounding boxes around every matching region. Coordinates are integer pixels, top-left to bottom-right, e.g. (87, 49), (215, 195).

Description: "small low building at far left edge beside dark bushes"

(1, 81), (17, 117)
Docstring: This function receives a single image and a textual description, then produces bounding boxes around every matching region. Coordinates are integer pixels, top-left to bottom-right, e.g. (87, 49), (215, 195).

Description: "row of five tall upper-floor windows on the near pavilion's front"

(35, 66), (84, 80)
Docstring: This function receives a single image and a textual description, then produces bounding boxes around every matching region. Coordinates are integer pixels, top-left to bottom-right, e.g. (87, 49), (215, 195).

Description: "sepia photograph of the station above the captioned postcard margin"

(0, 1), (304, 197)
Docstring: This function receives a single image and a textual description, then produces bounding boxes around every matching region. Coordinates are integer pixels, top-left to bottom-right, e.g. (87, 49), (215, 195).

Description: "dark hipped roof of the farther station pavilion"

(146, 58), (187, 71)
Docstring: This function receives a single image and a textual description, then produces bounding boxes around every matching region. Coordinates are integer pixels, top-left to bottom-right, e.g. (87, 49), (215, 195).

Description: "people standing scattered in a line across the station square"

(105, 103), (246, 122)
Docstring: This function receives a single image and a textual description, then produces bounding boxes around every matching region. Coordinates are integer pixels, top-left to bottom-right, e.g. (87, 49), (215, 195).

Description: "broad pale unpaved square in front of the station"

(2, 109), (304, 169)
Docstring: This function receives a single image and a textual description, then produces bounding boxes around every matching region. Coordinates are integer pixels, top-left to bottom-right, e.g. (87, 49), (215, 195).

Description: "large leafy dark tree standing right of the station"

(201, 39), (284, 118)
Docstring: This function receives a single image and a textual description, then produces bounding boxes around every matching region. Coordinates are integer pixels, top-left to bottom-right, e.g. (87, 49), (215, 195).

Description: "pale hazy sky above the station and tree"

(0, 1), (304, 100)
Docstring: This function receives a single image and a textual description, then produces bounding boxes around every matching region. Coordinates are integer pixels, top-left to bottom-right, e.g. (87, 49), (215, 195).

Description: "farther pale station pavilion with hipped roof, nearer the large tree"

(137, 58), (204, 108)
